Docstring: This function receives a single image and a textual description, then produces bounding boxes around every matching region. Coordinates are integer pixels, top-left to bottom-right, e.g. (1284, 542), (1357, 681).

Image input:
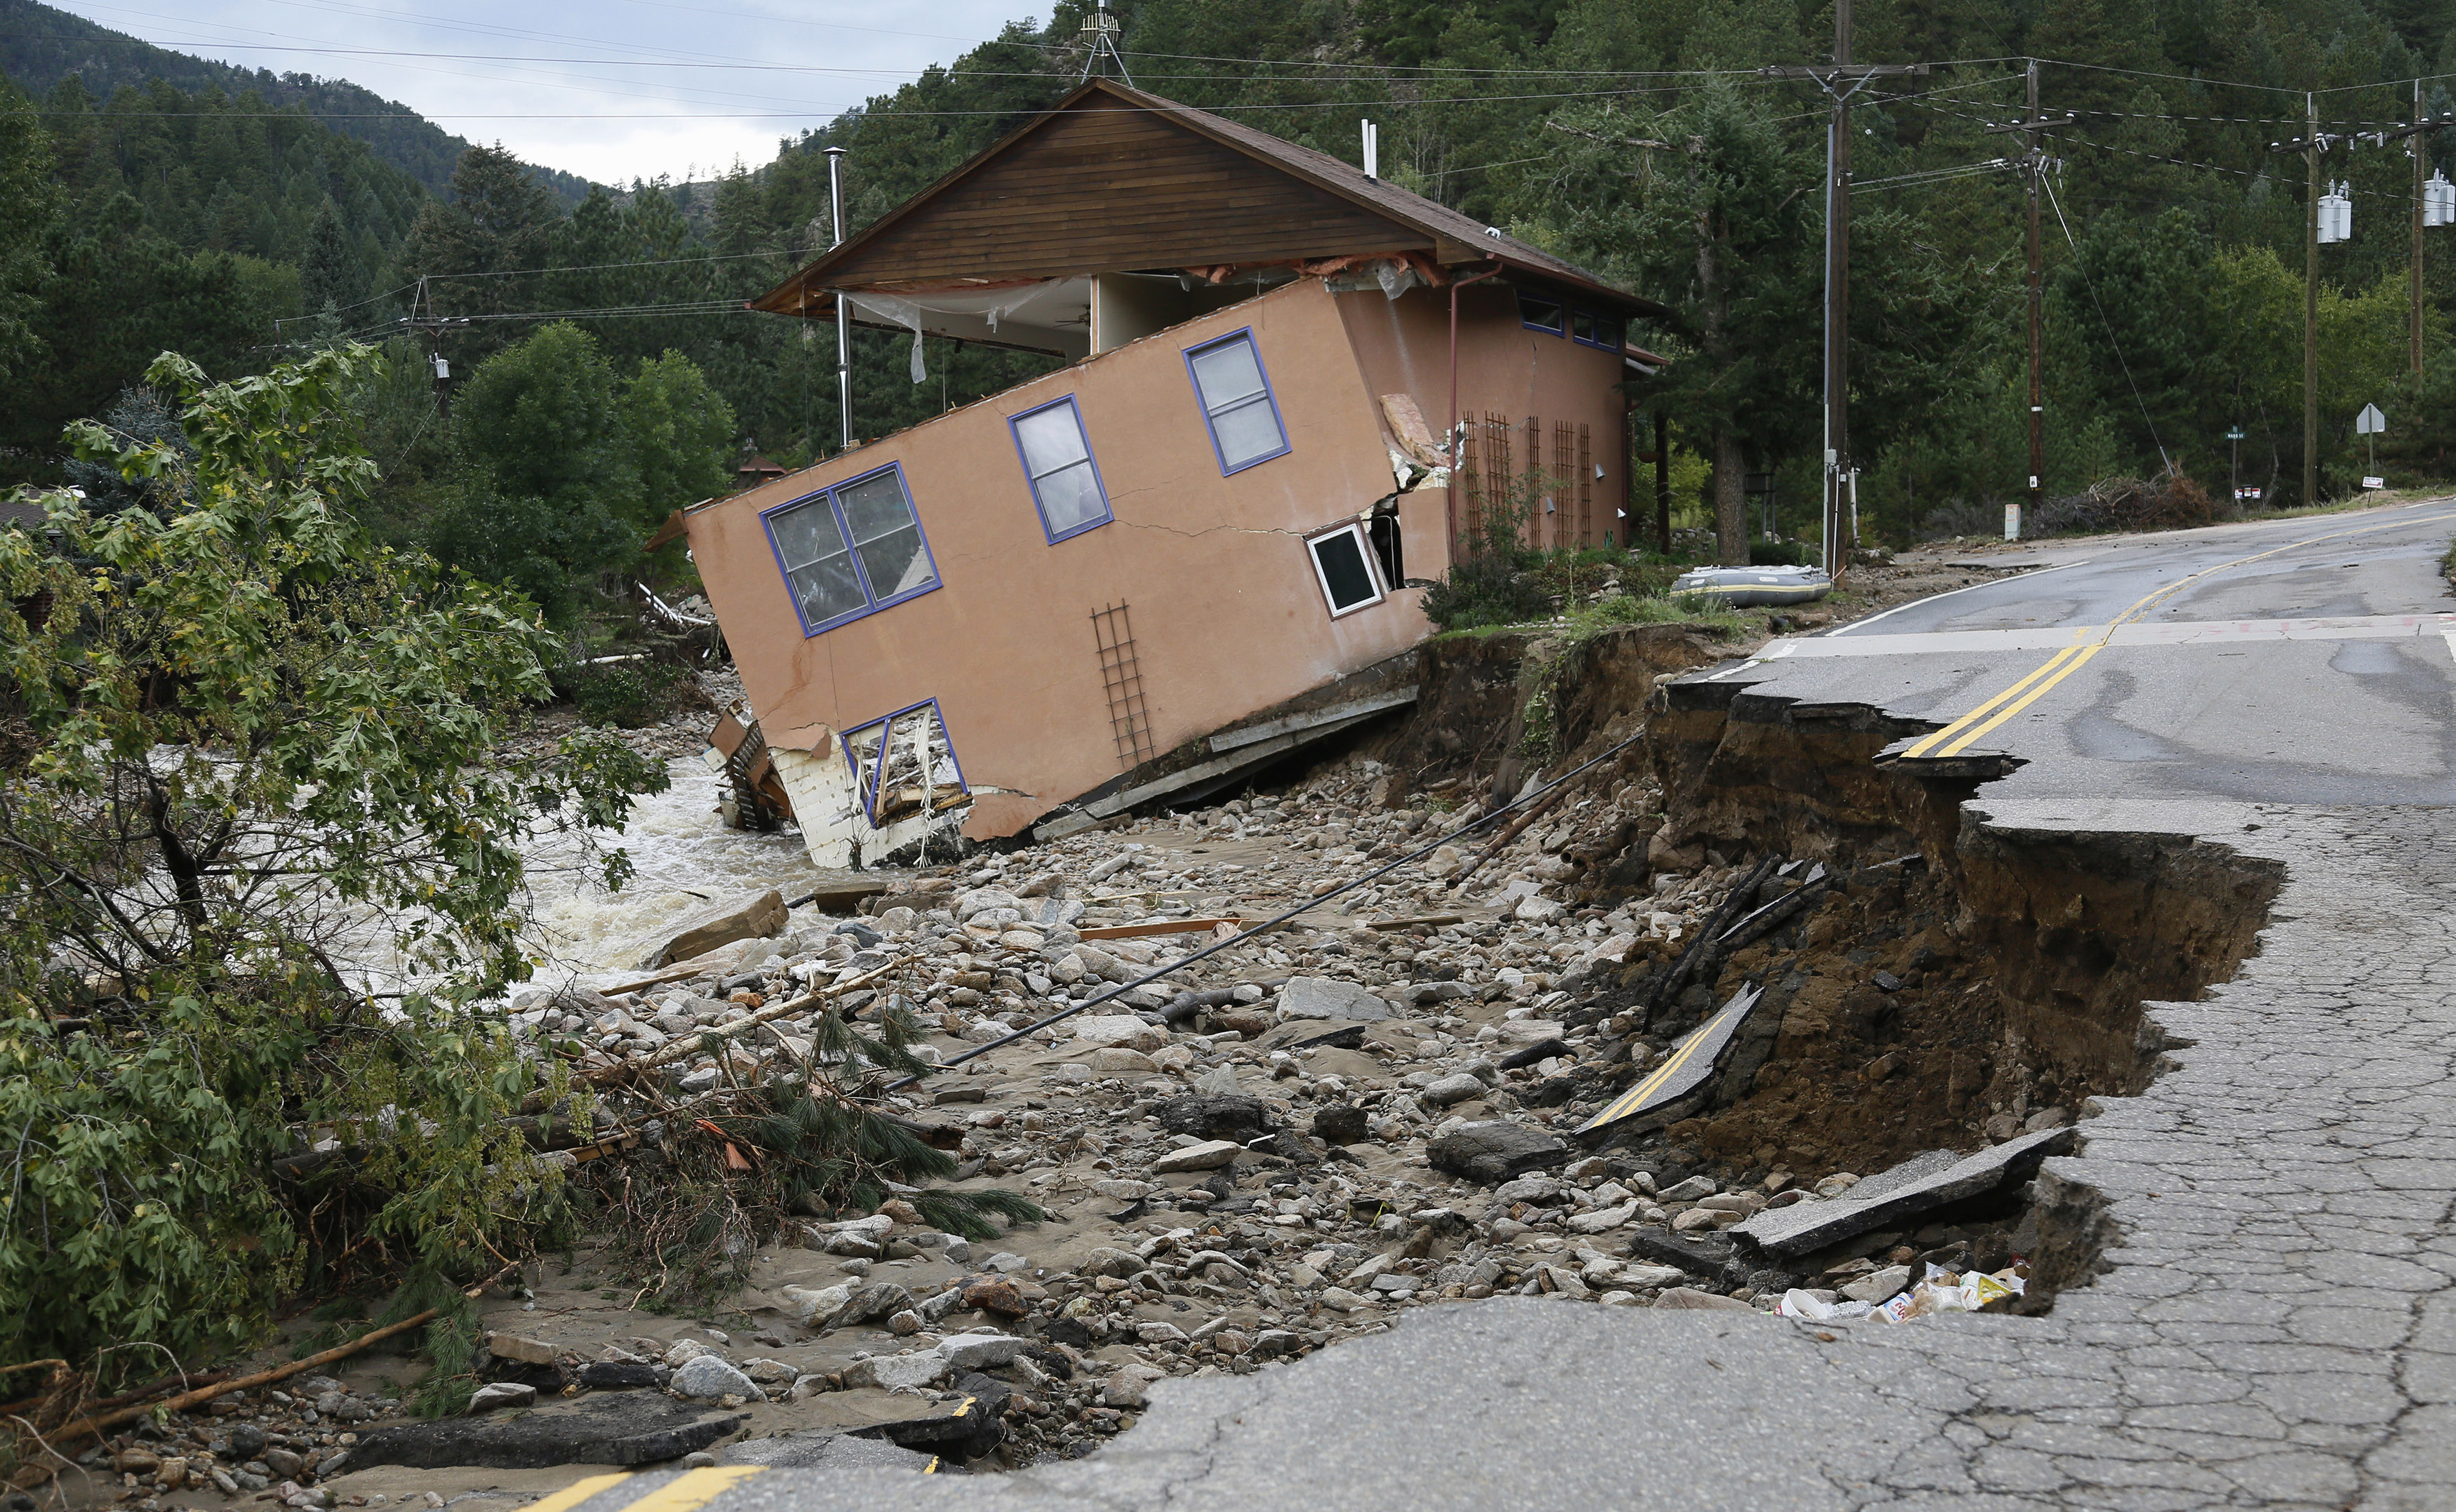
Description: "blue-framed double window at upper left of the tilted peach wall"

(759, 464), (938, 636)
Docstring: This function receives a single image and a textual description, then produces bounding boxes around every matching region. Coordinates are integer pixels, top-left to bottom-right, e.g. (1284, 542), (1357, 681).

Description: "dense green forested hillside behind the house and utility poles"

(10, 0), (2456, 572)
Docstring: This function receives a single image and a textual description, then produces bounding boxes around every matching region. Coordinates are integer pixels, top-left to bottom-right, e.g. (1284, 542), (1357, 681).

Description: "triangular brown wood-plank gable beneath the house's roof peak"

(761, 93), (1434, 295)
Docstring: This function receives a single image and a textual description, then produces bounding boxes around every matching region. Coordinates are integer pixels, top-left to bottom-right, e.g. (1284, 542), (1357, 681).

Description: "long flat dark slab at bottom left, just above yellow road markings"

(341, 1394), (745, 1471)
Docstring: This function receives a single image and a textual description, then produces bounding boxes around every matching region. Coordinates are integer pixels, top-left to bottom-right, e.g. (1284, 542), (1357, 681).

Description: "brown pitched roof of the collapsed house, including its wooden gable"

(752, 79), (1663, 314)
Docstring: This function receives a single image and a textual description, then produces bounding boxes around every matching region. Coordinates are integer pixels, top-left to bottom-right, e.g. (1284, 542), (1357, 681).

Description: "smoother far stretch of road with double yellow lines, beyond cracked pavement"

(1714, 501), (2456, 803)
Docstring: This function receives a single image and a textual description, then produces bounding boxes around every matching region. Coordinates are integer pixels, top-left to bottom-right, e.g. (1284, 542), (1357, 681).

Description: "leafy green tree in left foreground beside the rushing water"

(0, 346), (663, 1374)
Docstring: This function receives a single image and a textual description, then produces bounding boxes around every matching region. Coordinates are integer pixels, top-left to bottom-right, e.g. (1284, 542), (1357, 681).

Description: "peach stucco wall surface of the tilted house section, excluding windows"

(690, 280), (1439, 837)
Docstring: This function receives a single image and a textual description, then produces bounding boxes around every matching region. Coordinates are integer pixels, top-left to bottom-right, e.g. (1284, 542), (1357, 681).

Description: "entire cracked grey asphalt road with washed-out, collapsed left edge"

(457, 501), (2456, 1512)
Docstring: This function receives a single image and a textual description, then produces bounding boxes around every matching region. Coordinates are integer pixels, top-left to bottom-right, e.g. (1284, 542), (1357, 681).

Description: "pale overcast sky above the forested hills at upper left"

(52, 0), (1046, 184)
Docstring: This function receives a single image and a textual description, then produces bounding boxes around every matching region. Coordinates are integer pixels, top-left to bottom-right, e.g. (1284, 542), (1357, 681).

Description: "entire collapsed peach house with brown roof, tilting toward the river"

(686, 79), (1658, 864)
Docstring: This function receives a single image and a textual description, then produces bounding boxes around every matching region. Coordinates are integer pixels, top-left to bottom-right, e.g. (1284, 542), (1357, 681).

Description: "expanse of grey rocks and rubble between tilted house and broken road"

(95, 758), (2061, 1505)
